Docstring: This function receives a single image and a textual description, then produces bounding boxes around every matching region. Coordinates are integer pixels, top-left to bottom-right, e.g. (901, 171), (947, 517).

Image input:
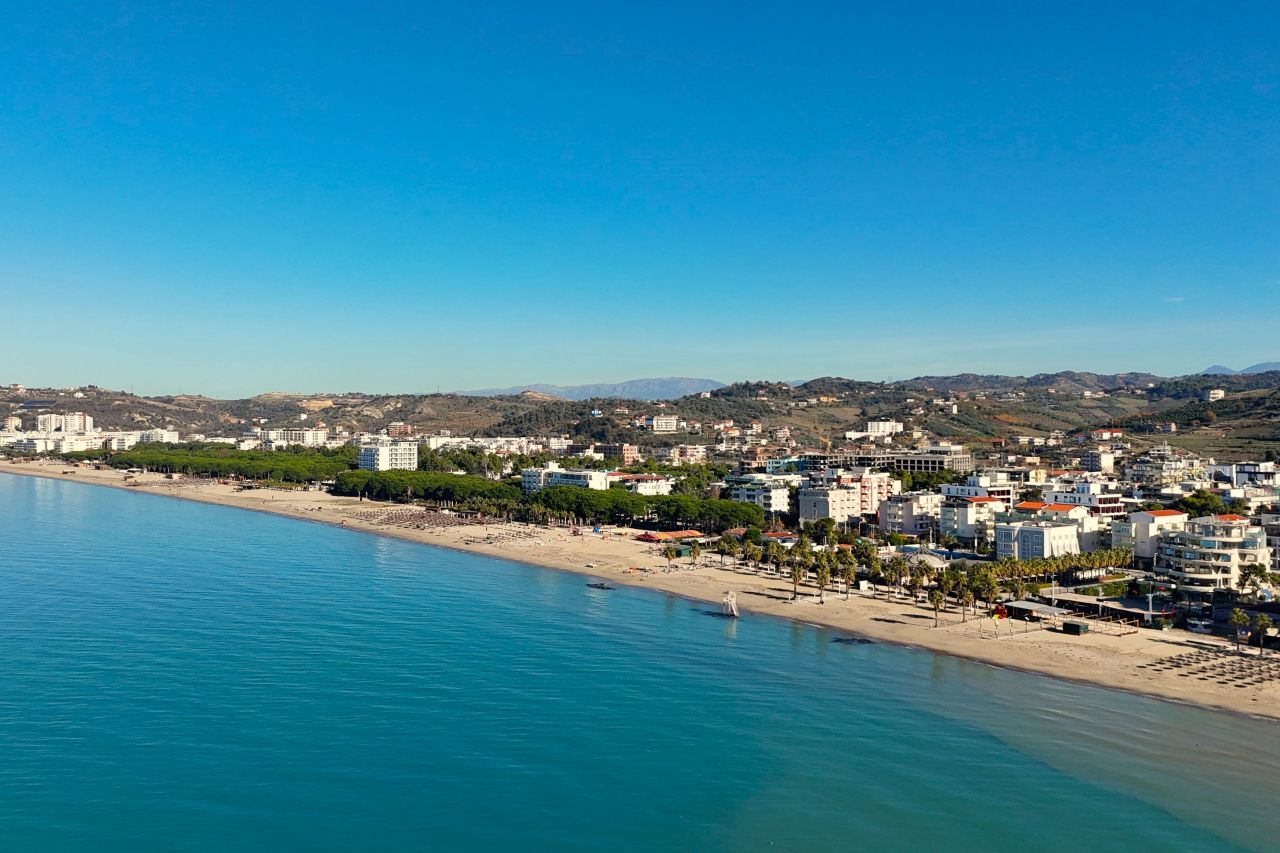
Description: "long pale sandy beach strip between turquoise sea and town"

(0, 461), (1280, 719)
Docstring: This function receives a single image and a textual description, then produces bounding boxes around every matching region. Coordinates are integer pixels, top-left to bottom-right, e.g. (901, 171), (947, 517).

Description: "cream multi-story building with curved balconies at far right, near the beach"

(1155, 515), (1271, 598)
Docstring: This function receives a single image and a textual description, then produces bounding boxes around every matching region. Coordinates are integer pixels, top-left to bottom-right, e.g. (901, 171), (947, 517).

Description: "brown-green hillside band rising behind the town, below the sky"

(10, 371), (1280, 455)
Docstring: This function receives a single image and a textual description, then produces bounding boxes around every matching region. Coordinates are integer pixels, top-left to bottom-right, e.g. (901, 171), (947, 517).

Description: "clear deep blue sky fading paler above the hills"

(0, 1), (1280, 396)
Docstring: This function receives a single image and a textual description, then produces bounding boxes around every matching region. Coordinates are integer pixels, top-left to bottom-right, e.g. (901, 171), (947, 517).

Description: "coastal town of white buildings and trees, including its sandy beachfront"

(0, 376), (1280, 710)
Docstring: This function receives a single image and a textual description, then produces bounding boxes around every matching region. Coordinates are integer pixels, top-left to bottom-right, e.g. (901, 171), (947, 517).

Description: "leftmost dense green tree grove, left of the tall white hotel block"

(92, 444), (358, 483)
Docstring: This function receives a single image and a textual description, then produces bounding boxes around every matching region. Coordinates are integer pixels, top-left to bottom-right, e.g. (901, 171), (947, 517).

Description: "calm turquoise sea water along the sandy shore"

(0, 475), (1280, 852)
